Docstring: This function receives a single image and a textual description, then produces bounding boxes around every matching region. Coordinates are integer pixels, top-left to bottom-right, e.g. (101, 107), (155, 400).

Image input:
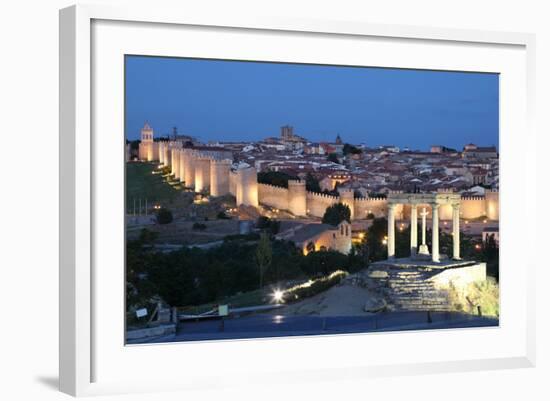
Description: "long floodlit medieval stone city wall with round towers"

(139, 130), (499, 220)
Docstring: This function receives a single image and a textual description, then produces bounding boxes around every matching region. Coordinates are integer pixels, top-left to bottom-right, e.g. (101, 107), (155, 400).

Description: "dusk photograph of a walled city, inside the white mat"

(124, 54), (500, 345)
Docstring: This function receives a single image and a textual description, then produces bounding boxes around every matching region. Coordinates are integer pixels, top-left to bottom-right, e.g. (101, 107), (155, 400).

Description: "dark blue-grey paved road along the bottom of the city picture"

(132, 312), (498, 344)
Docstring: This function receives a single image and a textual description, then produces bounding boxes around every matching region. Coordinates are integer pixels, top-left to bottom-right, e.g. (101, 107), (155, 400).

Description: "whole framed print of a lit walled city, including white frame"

(60, 6), (535, 395)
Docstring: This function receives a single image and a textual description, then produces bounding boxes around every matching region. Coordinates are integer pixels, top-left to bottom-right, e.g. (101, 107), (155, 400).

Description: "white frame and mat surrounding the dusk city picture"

(60, 5), (536, 395)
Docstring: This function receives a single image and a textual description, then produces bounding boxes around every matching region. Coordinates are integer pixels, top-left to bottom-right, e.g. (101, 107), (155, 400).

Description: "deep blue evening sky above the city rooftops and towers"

(126, 56), (499, 149)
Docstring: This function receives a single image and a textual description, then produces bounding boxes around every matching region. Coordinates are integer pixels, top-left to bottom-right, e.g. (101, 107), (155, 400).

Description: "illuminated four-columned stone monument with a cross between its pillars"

(388, 193), (460, 263)
